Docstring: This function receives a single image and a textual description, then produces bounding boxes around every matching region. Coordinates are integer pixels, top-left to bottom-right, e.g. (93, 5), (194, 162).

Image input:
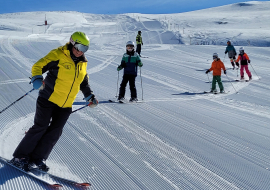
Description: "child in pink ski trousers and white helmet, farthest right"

(235, 47), (252, 80)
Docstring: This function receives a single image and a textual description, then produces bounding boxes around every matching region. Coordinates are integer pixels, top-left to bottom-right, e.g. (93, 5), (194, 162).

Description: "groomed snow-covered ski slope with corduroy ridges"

(0, 1), (270, 190)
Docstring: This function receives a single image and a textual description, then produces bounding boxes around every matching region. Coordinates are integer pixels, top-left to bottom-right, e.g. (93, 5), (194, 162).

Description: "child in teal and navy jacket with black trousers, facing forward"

(117, 41), (143, 102)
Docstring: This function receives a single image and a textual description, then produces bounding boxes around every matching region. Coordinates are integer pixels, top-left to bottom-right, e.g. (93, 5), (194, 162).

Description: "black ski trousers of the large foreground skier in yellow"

(13, 97), (72, 160)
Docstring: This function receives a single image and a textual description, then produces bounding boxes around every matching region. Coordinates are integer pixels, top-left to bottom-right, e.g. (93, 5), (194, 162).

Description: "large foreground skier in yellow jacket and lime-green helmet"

(11, 32), (98, 171)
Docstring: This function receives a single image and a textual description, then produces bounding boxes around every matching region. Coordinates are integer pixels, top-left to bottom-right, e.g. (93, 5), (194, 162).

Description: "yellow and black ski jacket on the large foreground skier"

(32, 43), (92, 108)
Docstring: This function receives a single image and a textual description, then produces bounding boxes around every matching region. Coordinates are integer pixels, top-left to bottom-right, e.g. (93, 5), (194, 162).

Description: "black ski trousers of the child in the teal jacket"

(119, 74), (137, 99)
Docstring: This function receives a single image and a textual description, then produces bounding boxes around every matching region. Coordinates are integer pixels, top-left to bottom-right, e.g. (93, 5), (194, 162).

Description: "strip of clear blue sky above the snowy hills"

(0, 0), (269, 14)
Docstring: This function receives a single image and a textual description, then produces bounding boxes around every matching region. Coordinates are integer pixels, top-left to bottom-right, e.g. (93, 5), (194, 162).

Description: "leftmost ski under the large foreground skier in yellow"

(0, 156), (63, 188)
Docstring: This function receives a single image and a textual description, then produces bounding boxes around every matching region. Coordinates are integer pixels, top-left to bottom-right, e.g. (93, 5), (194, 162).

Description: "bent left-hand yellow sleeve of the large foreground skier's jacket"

(32, 50), (59, 77)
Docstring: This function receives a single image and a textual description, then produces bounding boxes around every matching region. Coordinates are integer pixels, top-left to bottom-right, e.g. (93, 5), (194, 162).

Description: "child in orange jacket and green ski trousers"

(205, 53), (226, 93)
